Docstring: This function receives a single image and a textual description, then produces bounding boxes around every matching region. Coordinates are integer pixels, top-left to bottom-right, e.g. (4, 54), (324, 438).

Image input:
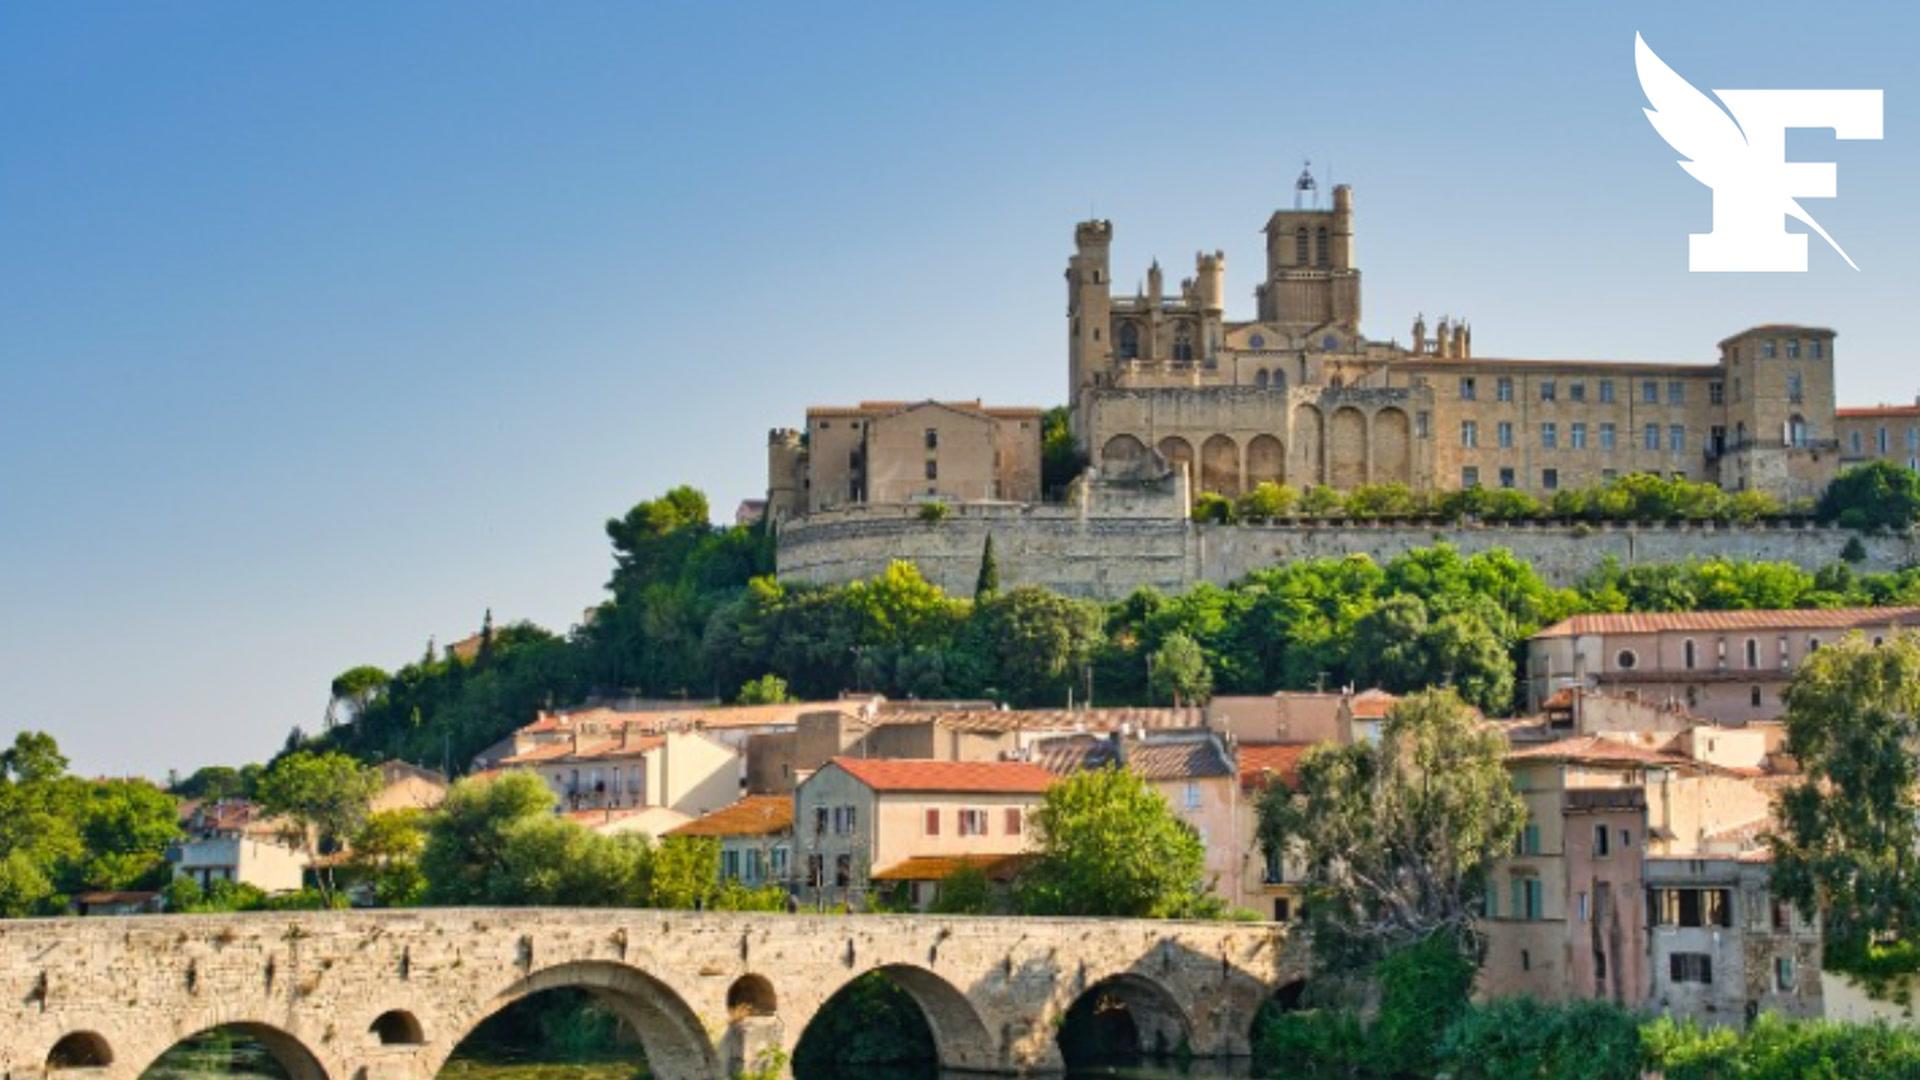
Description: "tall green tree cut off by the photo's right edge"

(1772, 634), (1920, 970)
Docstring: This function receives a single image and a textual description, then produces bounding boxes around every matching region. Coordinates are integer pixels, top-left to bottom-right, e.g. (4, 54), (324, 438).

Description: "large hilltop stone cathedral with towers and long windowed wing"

(1068, 177), (1839, 500)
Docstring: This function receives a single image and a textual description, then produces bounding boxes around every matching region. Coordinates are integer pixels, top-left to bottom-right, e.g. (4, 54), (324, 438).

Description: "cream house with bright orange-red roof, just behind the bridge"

(793, 757), (1054, 907)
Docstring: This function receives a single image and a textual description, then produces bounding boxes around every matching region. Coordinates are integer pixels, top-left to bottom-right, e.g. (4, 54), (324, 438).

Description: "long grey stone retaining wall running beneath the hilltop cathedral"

(780, 505), (1920, 600)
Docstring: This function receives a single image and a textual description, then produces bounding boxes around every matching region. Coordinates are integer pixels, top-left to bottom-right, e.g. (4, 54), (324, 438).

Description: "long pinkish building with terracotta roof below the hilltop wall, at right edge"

(1526, 607), (1920, 726)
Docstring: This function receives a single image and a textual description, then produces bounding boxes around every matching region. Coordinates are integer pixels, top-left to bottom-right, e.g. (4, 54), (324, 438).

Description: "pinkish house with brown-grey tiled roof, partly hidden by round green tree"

(1033, 732), (1246, 901)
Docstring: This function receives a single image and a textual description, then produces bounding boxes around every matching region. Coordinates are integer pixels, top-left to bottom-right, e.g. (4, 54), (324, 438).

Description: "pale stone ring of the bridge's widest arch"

(435, 961), (724, 1080)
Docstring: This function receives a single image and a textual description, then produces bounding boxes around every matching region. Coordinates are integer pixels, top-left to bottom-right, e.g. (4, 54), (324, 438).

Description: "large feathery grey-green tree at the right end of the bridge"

(1260, 690), (1526, 967)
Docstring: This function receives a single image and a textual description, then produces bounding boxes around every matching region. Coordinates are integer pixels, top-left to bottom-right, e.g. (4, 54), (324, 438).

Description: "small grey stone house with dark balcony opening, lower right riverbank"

(1645, 847), (1824, 1024)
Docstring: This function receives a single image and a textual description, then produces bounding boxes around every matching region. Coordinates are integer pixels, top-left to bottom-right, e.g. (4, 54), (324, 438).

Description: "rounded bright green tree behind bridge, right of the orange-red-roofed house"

(1016, 767), (1208, 919)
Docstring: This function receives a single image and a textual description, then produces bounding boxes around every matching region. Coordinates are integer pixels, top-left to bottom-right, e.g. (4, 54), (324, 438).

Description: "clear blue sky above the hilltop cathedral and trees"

(0, 0), (1920, 776)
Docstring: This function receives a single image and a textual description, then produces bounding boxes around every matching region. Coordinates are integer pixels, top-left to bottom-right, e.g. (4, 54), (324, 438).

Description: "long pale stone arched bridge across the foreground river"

(0, 909), (1304, 1080)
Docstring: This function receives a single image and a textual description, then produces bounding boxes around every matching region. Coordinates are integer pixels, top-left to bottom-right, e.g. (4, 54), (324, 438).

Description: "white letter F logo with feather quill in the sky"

(1634, 35), (1882, 273)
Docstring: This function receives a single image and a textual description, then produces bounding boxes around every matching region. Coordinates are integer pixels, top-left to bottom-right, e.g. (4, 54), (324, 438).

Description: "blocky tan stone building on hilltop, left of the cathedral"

(766, 400), (1041, 521)
